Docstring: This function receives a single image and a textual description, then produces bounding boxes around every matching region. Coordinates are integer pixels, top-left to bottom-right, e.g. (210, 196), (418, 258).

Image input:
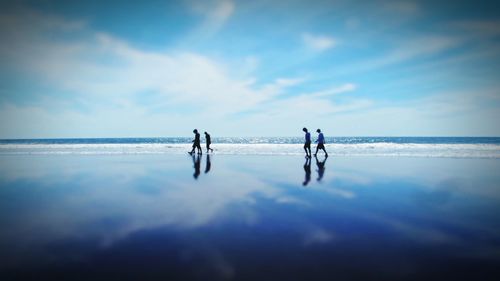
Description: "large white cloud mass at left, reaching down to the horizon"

(0, 10), (366, 138)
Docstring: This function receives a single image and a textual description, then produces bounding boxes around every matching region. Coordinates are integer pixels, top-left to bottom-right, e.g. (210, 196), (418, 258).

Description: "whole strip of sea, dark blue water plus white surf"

(0, 137), (500, 158)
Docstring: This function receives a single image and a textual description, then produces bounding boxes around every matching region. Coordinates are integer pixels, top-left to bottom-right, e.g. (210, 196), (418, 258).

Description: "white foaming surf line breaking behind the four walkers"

(0, 141), (500, 158)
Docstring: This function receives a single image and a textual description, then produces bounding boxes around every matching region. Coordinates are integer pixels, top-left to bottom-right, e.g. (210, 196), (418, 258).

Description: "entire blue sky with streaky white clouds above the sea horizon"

(0, 0), (500, 139)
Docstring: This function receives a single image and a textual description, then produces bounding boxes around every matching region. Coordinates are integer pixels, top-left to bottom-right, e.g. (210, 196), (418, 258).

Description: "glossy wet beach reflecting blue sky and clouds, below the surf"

(0, 155), (500, 280)
